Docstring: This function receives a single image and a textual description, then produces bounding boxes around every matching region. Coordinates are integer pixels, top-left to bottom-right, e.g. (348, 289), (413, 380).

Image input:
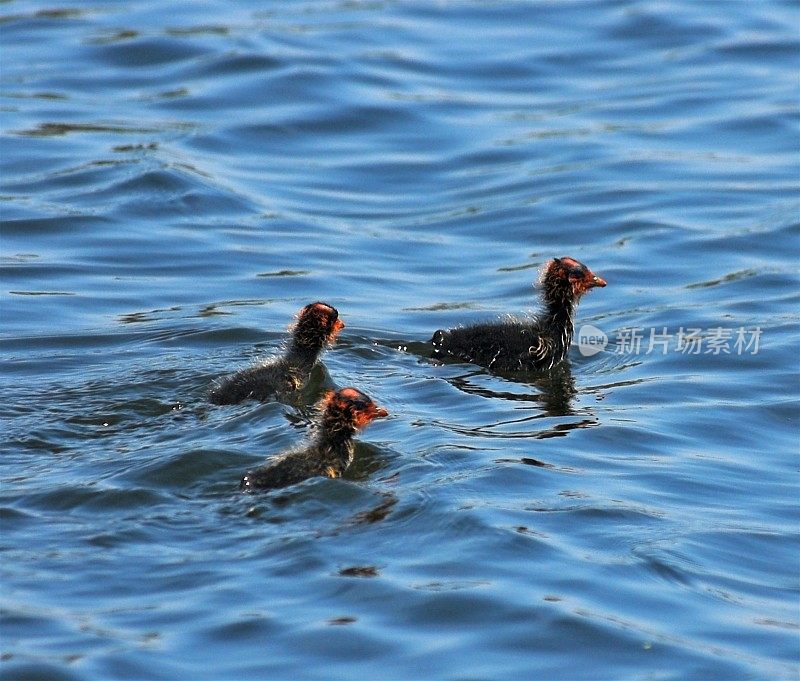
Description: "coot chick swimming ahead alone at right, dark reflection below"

(430, 258), (606, 371)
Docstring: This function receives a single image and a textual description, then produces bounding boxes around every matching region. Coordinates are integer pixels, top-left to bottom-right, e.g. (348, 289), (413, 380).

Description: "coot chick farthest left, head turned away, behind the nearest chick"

(209, 302), (344, 404)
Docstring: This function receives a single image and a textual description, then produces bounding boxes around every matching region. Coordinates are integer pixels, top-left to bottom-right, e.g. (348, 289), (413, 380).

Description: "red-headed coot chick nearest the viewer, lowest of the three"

(240, 388), (389, 491)
